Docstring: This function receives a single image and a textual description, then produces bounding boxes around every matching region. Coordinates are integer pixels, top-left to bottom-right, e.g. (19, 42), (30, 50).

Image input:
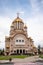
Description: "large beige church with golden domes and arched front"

(5, 16), (34, 55)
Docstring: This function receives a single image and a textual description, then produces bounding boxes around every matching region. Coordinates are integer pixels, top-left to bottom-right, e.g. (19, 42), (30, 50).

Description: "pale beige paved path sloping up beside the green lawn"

(12, 56), (42, 63)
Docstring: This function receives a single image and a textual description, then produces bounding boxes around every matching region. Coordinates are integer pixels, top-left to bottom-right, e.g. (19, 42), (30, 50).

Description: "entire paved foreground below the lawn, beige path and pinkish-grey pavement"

(0, 56), (43, 65)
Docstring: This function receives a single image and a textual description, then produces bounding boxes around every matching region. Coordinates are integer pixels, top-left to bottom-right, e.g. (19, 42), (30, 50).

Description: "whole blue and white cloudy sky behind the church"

(0, 0), (43, 49)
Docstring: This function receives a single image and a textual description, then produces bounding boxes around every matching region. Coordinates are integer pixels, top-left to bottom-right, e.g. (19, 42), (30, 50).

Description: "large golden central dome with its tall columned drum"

(11, 13), (24, 30)
